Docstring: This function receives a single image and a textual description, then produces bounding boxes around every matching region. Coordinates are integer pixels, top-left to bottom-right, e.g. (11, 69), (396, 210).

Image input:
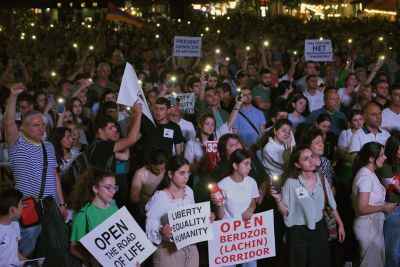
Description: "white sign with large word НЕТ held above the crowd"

(304, 40), (333, 61)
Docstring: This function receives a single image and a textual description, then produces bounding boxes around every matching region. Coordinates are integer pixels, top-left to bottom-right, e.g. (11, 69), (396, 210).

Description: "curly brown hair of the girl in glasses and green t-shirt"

(68, 167), (115, 211)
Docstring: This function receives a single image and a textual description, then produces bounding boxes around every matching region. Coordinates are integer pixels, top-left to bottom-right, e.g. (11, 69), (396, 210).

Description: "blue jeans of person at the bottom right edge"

(383, 208), (400, 267)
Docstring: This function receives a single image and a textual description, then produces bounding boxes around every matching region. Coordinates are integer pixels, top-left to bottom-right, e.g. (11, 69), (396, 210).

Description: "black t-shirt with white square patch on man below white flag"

(135, 115), (185, 157)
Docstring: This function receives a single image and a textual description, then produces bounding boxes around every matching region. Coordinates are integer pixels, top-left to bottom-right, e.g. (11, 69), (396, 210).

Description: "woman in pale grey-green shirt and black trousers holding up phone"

(271, 145), (345, 267)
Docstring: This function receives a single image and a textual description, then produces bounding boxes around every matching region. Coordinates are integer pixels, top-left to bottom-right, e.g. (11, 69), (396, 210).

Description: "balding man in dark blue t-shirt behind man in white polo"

(307, 88), (347, 136)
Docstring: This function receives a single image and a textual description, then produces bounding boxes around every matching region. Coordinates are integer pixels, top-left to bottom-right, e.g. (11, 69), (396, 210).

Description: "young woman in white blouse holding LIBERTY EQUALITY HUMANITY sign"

(146, 156), (199, 267)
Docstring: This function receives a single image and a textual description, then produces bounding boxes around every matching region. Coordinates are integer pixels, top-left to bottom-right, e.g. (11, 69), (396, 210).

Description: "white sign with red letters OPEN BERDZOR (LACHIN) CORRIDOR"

(208, 213), (276, 267)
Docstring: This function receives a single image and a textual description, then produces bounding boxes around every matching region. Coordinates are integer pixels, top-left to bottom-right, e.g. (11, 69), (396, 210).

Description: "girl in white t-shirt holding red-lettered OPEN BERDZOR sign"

(211, 149), (259, 267)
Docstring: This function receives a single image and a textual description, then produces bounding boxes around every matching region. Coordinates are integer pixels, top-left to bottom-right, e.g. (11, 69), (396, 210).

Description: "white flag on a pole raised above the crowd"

(117, 63), (154, 123)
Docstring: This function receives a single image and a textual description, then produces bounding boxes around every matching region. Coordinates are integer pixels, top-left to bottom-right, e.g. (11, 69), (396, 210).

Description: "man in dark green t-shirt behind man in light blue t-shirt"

(252, 69), (272, 118)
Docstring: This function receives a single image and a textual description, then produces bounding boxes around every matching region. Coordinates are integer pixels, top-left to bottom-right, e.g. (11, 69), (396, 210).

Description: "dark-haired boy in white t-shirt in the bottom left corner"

(0, 189), (26, 266)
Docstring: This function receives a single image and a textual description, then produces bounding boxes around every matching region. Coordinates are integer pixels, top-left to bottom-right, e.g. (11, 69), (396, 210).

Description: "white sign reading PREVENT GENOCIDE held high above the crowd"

(174, 36), (201, 57)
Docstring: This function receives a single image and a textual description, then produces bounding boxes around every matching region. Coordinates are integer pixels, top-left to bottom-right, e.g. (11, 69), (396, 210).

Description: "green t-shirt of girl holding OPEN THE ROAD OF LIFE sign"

(70, 203), (118, 242)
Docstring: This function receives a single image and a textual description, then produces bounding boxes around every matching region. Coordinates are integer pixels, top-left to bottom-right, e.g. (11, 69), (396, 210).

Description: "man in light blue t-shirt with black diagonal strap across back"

(232, 88), (267, 147)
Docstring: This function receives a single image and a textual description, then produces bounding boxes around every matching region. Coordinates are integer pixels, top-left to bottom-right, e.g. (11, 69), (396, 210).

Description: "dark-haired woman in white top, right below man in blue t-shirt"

(261, 119), (292, 176)
